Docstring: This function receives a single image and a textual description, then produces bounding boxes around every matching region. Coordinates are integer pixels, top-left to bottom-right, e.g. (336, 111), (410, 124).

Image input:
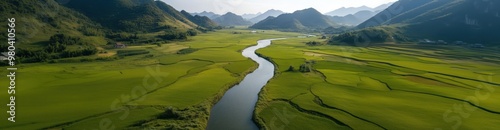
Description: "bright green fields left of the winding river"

(0, 29), (298, 130)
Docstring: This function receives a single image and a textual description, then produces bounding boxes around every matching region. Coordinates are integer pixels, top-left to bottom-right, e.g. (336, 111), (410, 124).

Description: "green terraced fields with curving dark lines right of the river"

(254, 38), (500, 129)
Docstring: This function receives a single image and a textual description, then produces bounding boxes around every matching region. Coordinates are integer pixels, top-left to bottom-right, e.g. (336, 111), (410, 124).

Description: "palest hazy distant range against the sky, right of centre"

(325, 2), (393, 16)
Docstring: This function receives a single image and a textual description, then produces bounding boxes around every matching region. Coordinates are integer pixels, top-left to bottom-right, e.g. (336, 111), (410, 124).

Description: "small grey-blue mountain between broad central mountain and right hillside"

(328, 10), (376, 26)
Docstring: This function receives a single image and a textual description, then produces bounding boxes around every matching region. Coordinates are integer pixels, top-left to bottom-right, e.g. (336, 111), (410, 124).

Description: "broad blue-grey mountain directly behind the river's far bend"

(251, 8), (336, 30)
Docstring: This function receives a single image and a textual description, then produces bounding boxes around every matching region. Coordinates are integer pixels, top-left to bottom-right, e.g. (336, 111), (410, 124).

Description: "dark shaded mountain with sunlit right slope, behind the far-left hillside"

(65, 0), (197, 32)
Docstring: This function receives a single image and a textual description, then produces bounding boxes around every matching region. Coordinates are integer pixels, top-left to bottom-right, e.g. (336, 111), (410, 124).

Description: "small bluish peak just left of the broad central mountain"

(214, 12), (252, 26)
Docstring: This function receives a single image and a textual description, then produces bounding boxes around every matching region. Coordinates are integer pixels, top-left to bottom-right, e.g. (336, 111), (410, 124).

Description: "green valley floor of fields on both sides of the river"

(0, 29), (500, 130)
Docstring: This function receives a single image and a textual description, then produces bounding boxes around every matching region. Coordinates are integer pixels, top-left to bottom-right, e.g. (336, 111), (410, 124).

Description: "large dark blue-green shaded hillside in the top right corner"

(357, 0), (500, 45)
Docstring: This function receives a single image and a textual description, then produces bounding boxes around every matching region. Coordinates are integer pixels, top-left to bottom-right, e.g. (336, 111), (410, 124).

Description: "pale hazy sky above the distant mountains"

(162, 0), (397, 14)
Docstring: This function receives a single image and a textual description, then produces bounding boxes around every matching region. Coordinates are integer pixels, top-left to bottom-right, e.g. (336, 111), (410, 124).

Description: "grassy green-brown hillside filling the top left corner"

(0, 0), (103, 44)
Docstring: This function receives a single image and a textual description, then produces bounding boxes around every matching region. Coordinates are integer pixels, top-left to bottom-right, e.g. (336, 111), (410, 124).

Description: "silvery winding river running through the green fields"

(207, 39), (279, 130)
